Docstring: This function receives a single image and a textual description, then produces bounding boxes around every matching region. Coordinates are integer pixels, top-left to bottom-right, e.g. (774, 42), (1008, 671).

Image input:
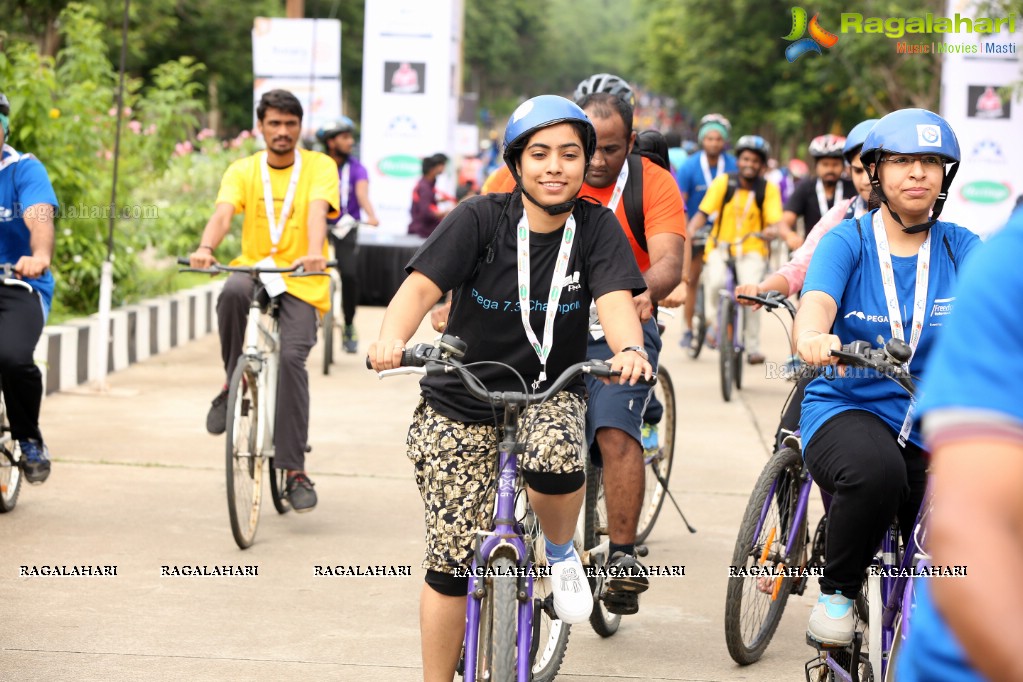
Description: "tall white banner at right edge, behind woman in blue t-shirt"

(941, 0), (1023, 235)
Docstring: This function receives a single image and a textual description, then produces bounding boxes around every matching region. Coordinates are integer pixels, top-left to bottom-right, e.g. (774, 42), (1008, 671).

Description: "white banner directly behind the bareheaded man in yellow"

(253, 16), (341, 139)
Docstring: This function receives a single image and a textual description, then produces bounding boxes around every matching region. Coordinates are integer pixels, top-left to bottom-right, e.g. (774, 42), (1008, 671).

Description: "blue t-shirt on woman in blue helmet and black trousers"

(799, 211), (980, 446)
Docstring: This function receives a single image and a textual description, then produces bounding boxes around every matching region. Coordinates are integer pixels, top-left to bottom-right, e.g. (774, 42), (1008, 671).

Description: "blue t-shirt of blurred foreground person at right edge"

(898, 209), (1023, 682)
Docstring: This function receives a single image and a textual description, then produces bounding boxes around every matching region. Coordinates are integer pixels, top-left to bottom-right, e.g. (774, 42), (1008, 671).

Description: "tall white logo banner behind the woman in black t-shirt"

(360, 0), (461, 236)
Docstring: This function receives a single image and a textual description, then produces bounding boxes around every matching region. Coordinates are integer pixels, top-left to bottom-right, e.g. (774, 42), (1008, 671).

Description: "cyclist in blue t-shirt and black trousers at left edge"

(0, 93), (58, 484)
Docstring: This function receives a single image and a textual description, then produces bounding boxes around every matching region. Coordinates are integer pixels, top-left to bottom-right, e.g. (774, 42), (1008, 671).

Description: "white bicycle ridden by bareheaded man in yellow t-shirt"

(178, 258), (332, 549)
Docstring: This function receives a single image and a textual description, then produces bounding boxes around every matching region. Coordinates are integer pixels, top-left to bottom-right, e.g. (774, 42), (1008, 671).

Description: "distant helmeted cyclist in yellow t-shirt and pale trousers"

(688, 135), (782, 365)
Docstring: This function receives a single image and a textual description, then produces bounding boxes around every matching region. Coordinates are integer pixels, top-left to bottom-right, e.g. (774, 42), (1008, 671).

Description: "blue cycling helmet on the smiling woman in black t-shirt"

(504, 95), (596, 216)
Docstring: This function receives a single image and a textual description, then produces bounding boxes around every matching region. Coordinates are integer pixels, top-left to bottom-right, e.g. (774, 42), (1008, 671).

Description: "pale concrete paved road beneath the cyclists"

(0, 309), (819, 682)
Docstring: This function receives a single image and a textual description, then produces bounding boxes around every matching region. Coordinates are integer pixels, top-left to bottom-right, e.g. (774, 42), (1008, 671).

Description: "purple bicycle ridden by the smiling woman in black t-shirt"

(367, 334), (638, 682)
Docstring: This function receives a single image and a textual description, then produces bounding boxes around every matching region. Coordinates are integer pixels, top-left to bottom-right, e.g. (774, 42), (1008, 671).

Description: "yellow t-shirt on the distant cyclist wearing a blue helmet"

(700, 173), (782, 259)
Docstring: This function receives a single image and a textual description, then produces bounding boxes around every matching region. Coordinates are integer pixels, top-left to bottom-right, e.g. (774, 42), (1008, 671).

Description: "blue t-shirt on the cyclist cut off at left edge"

(0, 144), (58, 316)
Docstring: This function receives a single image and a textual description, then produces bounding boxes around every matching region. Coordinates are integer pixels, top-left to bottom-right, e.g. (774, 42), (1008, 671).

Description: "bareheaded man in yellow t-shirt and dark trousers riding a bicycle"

(190, 90), (341, 511)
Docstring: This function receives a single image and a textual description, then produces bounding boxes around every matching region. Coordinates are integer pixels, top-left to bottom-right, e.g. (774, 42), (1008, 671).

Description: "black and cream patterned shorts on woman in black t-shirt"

(406, 391), (586, 574)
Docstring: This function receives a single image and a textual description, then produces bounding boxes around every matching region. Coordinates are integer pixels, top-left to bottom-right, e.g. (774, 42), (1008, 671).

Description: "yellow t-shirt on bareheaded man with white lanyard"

(217, 149), (341, 313)
